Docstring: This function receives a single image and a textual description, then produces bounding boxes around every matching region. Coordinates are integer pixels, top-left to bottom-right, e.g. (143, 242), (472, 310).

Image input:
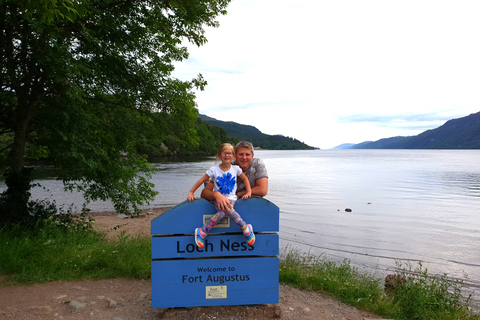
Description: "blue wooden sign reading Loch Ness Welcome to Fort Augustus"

(151, 198), (279, 308)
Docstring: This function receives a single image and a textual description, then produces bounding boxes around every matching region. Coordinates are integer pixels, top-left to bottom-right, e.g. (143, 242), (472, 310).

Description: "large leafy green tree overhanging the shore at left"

(0, 0), (230, 218)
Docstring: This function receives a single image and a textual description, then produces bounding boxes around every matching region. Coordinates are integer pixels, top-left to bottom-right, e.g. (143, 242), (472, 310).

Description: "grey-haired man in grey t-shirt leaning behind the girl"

(201, 141), (268, 210)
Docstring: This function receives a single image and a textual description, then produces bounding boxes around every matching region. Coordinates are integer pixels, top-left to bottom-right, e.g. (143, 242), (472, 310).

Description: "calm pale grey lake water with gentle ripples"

(0, 150), (480, 299)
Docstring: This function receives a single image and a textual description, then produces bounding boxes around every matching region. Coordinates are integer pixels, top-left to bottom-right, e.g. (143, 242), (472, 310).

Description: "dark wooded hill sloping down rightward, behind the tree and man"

(198, 114), (315, 150)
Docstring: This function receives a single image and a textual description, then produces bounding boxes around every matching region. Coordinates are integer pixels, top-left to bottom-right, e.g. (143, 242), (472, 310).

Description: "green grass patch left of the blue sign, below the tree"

(0, 220), (150, 284)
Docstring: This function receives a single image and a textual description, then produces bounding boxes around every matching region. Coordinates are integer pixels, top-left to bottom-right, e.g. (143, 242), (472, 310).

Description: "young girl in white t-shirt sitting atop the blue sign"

(187, 143), (255, 248)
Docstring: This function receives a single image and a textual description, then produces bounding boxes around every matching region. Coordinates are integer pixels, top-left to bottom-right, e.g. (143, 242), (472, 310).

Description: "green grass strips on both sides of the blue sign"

(0, 220), (476, 320)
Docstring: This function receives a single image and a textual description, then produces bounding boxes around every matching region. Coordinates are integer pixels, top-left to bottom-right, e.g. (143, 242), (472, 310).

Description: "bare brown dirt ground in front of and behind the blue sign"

(0, 209), (390, 320)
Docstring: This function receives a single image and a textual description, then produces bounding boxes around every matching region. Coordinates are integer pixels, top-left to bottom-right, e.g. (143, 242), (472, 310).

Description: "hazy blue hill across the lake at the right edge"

(350, 112), (480, 149)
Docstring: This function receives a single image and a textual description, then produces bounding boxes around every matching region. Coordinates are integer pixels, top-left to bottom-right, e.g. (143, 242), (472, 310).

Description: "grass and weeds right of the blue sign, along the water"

(280, 250), (478, 320)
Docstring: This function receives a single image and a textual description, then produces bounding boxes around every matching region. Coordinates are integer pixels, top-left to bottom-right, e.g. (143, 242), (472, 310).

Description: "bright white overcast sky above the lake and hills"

(174, 0), (480, 149)
